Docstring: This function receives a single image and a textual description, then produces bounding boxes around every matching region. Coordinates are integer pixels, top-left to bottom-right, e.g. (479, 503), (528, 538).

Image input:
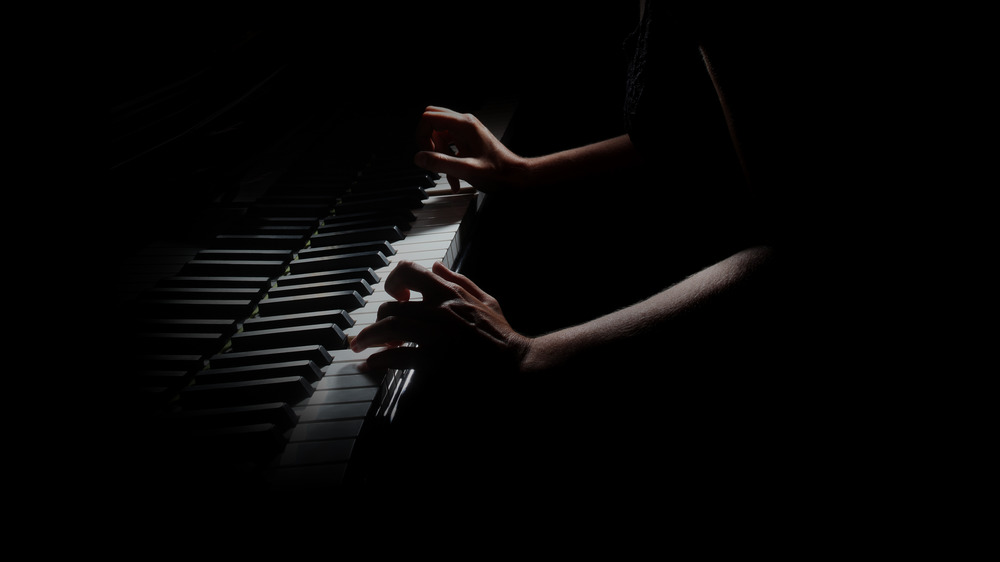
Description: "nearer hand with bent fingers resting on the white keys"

(351, 261), (529, 370)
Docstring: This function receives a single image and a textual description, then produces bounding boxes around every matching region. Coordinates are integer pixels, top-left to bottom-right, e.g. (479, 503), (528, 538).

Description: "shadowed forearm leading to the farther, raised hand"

(520, 135), (639, 188)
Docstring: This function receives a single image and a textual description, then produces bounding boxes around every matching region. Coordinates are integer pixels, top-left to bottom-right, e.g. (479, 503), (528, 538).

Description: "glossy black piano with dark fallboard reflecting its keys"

(101, 3), (648, 501)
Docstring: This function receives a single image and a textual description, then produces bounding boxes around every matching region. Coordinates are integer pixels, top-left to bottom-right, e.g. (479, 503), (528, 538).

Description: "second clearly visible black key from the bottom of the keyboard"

(180, 377), (313, 408)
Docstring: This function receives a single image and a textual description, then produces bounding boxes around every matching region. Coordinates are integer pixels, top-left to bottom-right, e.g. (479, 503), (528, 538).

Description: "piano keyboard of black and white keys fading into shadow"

(122, 150), (477, 492)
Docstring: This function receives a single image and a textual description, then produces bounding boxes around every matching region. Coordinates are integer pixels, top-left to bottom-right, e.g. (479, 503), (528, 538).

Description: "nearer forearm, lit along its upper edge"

(522, 247), (774, 373)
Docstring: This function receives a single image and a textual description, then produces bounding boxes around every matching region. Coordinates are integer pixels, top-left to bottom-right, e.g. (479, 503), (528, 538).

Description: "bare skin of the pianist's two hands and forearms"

(351, 107), (774, 376)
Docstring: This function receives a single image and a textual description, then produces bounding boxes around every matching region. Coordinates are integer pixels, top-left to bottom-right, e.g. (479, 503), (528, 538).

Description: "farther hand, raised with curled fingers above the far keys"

(414, 106), (527, 192)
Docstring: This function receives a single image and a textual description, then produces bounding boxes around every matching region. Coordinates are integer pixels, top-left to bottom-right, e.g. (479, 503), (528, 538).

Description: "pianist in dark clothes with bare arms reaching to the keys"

(353, 2), (776, 374)
